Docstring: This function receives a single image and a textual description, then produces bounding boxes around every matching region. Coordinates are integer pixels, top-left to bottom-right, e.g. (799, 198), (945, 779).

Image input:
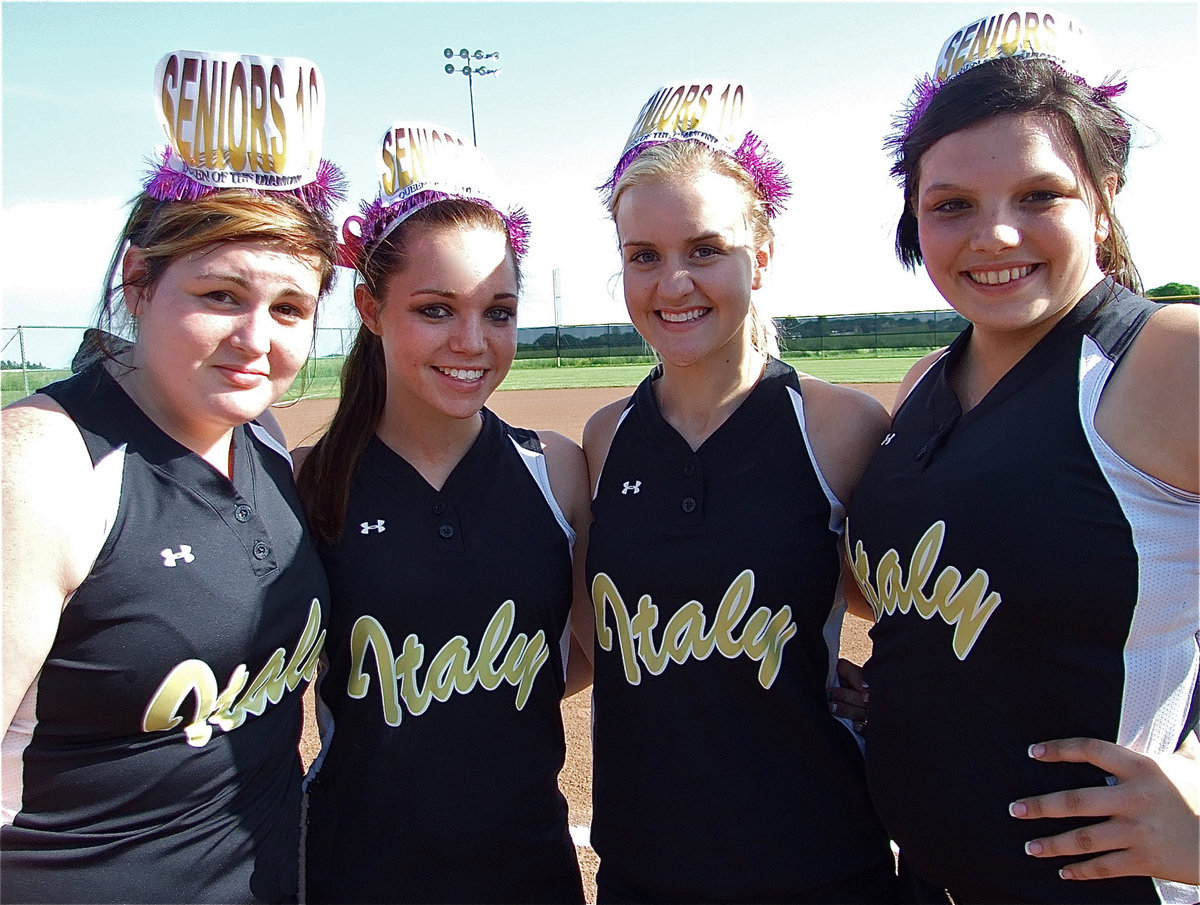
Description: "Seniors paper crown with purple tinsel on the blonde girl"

(600, 82), (792, 217)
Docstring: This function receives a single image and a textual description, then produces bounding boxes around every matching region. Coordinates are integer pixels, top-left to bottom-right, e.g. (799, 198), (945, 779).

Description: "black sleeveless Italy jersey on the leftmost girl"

(0, 365), (328, 903)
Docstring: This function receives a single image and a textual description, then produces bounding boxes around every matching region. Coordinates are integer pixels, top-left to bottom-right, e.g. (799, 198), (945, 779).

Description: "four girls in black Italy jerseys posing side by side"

(0, 13), (1200, 903)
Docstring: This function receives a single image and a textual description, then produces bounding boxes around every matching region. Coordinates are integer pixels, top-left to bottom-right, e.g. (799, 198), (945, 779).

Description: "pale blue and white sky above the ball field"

(0, 0), (1200, 358)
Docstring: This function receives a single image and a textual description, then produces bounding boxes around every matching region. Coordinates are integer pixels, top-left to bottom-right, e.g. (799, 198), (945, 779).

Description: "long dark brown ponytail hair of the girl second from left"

(296, 199), (520, 544)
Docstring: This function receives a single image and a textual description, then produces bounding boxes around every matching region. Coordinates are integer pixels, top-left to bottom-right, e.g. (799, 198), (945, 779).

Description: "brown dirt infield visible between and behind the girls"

(274, 383), (898, 903)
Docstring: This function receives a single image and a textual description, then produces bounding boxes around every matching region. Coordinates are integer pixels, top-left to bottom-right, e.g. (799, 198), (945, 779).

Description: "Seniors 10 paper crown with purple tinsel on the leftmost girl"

(145, 50), (344, 214)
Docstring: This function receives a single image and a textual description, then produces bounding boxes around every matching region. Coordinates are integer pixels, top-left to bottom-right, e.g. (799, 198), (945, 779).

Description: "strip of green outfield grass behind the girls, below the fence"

(2, 349), (924, 404)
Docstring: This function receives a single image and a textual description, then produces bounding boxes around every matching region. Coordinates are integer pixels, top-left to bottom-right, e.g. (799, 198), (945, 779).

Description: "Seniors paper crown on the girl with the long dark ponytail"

(342, 122), (529, 266)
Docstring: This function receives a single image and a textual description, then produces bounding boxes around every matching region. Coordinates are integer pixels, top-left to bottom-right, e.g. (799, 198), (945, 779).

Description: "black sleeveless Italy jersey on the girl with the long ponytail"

(305, 409), (583, 903)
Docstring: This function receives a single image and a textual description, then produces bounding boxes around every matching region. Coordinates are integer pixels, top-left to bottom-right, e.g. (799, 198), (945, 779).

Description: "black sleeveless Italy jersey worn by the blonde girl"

(587, 359), (892, 901)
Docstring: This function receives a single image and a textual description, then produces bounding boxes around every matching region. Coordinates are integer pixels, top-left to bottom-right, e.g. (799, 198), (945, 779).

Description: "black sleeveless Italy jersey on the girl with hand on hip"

(847, 281), (1200, 903)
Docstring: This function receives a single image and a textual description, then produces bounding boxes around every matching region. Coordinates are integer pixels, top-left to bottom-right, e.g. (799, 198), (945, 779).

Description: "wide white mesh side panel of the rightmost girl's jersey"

(1079, 337), (1200, 904)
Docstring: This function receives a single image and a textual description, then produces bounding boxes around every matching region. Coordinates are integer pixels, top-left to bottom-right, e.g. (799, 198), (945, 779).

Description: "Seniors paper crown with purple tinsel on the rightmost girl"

(884, 8), (1126, 154)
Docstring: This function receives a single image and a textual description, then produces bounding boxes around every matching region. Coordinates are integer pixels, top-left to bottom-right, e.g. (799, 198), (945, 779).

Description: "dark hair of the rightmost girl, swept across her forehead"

(892, 58), (1141, 292)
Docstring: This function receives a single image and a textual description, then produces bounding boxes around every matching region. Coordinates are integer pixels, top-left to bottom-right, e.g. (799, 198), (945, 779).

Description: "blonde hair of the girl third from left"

(608, 140), (780, 358)
